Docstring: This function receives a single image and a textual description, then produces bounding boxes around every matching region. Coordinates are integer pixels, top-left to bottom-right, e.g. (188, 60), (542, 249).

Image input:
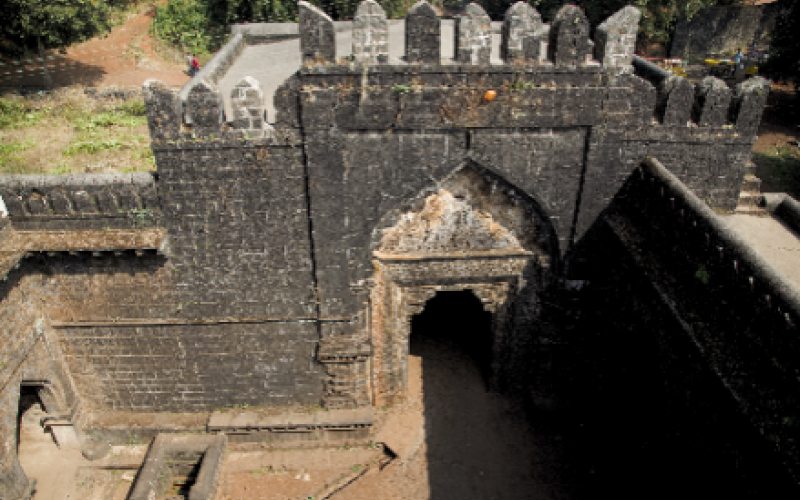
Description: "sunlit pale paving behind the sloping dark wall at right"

(724, 214), (800, 290)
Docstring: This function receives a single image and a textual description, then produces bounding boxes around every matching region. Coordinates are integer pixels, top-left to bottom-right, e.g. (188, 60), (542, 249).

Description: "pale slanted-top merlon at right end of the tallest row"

(595, 5), (642, 73)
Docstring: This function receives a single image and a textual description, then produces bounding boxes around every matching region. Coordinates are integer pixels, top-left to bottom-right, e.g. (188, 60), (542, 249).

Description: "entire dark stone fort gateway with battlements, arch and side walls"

(0, 0), (800, 500)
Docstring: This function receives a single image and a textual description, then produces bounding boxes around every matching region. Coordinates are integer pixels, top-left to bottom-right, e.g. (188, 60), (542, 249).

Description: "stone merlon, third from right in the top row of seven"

(500, 2), (543, 64)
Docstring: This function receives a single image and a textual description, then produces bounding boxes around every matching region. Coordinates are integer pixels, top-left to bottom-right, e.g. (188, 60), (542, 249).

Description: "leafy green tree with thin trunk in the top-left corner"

(0, 0), (114, 86)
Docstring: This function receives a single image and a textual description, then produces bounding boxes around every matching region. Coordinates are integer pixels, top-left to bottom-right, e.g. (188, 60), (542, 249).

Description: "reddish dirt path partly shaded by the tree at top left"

(0, 3), (189, 88)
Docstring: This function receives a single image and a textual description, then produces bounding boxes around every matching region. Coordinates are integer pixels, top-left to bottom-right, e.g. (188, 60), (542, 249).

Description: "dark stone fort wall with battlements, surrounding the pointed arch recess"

(4, 2), (768, 411)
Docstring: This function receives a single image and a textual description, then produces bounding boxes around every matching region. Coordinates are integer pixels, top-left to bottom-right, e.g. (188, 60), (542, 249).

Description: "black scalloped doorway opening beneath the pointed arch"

(409, 290), (493, 388)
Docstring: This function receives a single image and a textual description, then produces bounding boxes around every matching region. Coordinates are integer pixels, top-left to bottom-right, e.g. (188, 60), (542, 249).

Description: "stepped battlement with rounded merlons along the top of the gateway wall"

(144, 0), (769, 144)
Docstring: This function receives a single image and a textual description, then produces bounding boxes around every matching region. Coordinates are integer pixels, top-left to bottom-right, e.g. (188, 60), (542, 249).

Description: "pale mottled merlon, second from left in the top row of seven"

(353, 0), (389, 64)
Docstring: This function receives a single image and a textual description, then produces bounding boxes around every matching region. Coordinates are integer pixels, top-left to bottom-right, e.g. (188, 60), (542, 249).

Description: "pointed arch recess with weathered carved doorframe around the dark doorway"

(370, 159), (559, 406)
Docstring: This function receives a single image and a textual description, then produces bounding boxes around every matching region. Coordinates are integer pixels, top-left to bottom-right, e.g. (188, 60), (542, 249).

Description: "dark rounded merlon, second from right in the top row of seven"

(547, 5), (594, 66)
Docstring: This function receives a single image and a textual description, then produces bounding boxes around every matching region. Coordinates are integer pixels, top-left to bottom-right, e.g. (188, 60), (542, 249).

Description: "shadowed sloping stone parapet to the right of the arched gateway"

(606, 157), (800, 482)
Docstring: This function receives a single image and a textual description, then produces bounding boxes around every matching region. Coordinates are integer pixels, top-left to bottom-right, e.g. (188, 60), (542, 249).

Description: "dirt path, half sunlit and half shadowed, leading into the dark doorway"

(332, 292), (578, 500)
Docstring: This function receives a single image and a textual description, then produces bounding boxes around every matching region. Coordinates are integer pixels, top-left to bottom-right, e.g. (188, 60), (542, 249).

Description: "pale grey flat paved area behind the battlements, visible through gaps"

(212, 20), (501, 122)
